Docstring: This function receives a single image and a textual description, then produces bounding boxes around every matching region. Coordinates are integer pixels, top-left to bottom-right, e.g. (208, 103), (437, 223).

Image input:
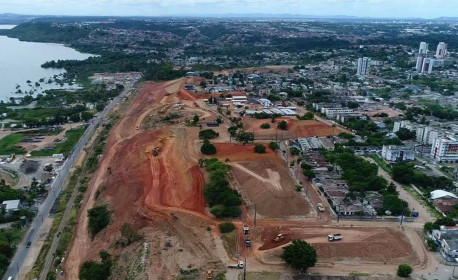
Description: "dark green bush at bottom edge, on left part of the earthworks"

(78, 250), (113, 280)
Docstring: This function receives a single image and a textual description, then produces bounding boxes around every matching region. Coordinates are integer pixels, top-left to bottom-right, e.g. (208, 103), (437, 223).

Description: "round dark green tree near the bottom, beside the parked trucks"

(281, 239), (317, 271)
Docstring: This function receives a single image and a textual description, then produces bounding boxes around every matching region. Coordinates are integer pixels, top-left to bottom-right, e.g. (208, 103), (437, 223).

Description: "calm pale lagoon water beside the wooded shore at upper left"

(0, 25), (91, 100)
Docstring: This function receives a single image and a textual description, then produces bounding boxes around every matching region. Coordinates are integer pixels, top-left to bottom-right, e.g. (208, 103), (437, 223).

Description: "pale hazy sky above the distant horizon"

(0, 0), (458, 18)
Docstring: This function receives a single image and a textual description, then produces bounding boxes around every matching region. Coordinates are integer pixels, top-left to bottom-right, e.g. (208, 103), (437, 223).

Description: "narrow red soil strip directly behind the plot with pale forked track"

(213, 143), (280, 161)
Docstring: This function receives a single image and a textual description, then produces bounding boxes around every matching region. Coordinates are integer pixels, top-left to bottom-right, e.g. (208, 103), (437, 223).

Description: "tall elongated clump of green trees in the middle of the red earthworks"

(204, 159), (242, 218)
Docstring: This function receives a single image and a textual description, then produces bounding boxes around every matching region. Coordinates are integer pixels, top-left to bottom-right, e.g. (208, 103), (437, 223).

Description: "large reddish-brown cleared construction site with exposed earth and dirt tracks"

(61, 78), (434, 280)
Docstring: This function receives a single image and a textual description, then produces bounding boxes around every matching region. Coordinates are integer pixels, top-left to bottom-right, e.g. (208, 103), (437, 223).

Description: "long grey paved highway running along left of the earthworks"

(3, 81), (136, 280)
